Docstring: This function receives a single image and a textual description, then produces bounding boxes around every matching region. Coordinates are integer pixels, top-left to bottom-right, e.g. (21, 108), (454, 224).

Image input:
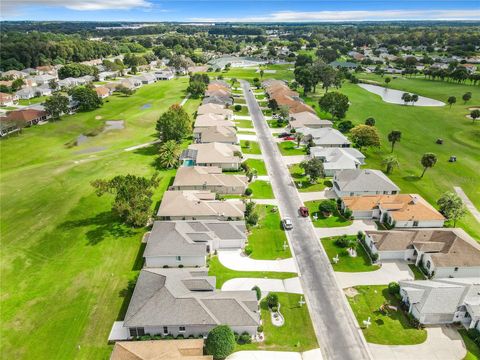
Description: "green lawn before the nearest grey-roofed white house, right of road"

(348, 285), (427, 345)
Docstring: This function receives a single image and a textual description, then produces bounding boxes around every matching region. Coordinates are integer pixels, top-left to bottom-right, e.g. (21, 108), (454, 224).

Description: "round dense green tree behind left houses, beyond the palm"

(155, 104), (192, 142)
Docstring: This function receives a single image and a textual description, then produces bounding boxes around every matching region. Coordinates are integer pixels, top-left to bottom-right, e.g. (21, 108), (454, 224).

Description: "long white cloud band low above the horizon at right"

(190, 9), (480, 22)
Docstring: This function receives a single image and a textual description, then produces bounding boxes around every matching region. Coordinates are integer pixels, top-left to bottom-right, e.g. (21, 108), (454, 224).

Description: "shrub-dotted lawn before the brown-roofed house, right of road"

(322, 235), (379, 272)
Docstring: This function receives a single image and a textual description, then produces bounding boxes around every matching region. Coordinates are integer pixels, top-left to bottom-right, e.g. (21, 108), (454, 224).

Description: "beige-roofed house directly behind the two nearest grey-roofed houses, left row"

(157, 190), (245, 220)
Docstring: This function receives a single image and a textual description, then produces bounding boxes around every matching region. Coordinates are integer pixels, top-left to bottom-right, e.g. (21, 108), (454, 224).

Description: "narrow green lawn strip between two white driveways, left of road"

(208, 256), (297, 289)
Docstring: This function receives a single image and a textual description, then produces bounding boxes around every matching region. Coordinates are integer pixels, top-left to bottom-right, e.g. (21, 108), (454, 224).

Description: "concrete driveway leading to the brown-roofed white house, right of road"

(335, 260), (414, 289)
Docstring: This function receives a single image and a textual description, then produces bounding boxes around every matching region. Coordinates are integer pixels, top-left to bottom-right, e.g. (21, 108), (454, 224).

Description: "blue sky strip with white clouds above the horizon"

(0, 0), (480, 22)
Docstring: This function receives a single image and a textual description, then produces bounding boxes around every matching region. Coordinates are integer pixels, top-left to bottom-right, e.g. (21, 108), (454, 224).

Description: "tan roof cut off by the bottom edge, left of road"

(110, 339), (213, 360)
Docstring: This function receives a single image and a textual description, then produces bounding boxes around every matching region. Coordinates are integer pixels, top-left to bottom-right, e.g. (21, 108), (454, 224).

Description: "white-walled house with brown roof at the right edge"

(365, 228), (480, 278)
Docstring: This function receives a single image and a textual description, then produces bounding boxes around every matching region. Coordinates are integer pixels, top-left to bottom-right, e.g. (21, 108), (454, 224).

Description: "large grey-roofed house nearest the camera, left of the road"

(123, 268), (260, 338)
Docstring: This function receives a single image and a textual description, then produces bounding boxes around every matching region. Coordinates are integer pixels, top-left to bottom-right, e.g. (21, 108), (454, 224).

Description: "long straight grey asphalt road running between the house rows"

(241, 81), (371, 360)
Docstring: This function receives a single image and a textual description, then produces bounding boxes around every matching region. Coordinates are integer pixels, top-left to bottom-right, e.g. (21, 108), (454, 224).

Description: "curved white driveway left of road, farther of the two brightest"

(218, 250), (297, 273)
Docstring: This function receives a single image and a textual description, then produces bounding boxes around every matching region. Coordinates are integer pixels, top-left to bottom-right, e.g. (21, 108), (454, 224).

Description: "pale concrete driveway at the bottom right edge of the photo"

(368, 327), (467, 360)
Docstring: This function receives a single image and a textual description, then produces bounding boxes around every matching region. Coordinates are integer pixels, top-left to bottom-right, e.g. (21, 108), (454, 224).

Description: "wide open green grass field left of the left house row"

(0, 79), (198, 359)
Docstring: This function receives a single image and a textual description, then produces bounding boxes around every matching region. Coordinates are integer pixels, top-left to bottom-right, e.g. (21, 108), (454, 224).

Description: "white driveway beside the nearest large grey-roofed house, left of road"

(222, 277), (303, 298)
